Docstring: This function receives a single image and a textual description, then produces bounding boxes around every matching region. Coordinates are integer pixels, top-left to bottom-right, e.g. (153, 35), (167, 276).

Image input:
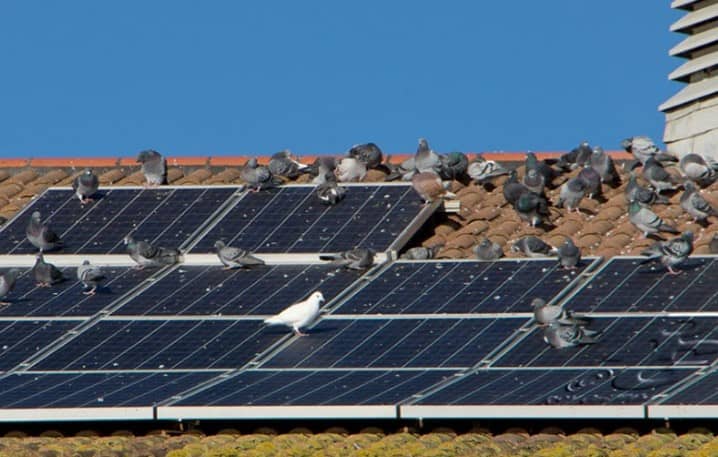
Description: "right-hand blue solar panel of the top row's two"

(193, 185), (424, 253)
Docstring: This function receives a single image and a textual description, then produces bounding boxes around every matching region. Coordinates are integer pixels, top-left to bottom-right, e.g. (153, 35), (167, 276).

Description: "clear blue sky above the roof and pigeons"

(0, 0), (681, 157)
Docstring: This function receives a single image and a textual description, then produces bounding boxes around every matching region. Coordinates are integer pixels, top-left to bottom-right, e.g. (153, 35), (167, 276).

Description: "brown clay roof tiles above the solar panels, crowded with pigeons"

(0, 152), (718, 259)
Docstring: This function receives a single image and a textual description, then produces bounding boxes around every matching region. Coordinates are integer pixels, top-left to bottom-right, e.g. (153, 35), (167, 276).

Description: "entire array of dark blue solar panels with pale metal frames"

(0, 185), (718, 420)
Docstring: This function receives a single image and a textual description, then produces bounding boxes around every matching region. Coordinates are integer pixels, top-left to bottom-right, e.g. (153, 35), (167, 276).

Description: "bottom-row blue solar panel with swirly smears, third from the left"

(417, 368), (693, 405)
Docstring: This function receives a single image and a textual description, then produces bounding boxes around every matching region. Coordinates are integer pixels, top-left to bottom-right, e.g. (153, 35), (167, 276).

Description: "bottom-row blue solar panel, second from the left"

(173, 370), (456, 406)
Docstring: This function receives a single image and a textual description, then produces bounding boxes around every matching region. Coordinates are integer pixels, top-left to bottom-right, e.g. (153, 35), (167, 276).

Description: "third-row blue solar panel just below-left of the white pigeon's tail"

(33, 320), (288, 371)
